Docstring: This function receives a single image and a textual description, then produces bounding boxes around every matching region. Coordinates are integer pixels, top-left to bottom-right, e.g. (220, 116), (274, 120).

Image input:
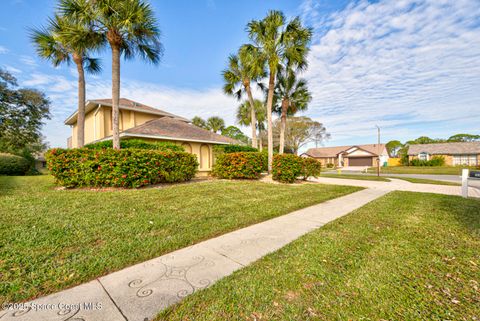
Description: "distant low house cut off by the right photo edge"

(408, 142), (480, 166)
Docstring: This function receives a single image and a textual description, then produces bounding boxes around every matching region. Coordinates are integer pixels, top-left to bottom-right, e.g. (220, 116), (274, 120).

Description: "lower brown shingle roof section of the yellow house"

(122, 117), (241, 144)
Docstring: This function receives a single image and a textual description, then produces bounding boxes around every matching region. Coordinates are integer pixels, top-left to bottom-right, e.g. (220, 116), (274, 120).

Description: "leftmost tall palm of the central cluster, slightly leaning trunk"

(222, 45), (266, 147)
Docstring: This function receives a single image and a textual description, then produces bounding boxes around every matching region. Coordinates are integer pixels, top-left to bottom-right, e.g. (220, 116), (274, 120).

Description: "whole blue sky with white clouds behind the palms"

(0, 0), (480, 148)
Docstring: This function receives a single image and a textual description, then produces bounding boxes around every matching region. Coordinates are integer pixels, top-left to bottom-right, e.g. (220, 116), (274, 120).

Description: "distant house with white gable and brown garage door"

(301, 144), (389, 167)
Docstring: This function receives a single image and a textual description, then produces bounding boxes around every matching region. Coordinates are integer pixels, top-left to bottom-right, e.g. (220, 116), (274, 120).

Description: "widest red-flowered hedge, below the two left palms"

(45, 148), (198, 188)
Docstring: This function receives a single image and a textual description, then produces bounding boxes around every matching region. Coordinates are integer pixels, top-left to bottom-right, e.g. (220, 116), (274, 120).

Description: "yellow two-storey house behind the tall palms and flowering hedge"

(65, 98), (239, 175)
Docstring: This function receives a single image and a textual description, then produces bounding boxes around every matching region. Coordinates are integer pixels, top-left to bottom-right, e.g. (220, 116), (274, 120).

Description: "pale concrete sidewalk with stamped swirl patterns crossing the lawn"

(0, 188), (390, 321)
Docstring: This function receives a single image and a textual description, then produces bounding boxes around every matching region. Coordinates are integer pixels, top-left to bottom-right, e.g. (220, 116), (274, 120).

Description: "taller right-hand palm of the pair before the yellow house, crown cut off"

(60, 0), (163, 149)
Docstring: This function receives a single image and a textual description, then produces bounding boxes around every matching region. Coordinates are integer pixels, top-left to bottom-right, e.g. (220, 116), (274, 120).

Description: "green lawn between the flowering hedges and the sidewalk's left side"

(0, 175), (359, 302)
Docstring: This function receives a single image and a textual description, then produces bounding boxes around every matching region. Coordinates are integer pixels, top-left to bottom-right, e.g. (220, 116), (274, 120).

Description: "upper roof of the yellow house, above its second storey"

(65, 98), (190, 125)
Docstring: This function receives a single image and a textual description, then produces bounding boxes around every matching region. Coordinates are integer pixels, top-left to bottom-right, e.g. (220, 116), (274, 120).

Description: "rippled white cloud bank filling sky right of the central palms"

(301, 0), (480, 145)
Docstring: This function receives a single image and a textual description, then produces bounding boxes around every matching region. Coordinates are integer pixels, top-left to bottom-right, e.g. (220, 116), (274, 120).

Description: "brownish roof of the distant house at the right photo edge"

(408, 142), (480, 155)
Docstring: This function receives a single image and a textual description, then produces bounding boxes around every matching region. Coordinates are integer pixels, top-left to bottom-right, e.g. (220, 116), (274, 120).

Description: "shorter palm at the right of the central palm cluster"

(274, 68), (312, 154)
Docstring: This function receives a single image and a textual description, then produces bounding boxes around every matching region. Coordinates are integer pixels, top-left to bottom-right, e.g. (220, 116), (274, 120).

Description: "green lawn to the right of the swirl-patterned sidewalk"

(158, 192), (480, 321)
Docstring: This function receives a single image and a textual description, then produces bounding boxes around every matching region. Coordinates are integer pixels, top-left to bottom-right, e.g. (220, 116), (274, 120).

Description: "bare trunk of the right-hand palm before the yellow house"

(112, 46), (120, 149)
